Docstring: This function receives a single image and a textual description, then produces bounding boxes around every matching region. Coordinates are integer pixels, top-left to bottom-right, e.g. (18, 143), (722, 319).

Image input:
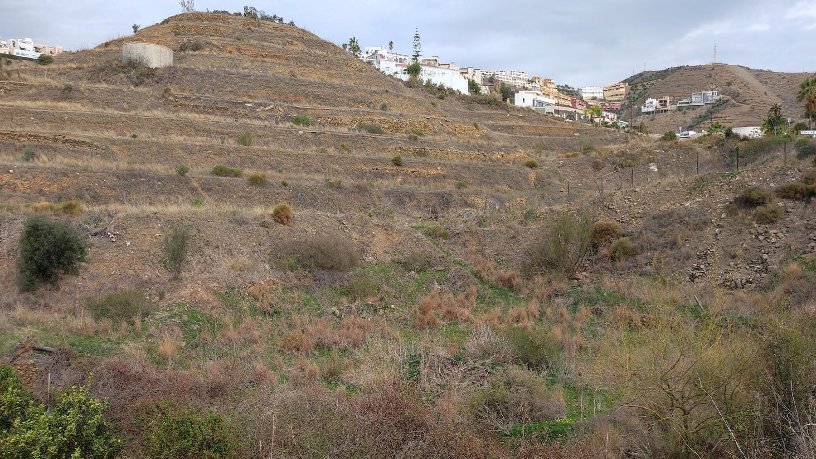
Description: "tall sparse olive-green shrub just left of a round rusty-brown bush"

(528, 214), (592, 275)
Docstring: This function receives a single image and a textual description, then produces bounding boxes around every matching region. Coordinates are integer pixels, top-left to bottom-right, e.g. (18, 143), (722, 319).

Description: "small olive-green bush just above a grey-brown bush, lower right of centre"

(505, 327), (564, 371)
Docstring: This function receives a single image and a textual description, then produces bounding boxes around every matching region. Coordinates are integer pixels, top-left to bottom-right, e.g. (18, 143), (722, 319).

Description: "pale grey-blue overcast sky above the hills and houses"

(0, 0), (816, 86)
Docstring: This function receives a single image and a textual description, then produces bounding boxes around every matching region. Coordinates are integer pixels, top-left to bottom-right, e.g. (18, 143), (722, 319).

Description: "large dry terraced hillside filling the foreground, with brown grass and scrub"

(0, 13), (816, 458)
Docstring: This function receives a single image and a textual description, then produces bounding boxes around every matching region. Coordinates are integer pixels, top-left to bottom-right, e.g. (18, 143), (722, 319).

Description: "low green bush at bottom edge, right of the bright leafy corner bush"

(144, 403), (239, 459)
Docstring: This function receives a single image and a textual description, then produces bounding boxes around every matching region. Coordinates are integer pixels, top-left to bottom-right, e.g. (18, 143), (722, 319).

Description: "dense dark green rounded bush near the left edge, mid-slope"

(17, 216), (87, 291)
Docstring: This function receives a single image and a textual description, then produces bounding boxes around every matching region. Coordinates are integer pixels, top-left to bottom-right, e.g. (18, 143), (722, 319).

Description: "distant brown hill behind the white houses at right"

(623, 64), (811, 132)
